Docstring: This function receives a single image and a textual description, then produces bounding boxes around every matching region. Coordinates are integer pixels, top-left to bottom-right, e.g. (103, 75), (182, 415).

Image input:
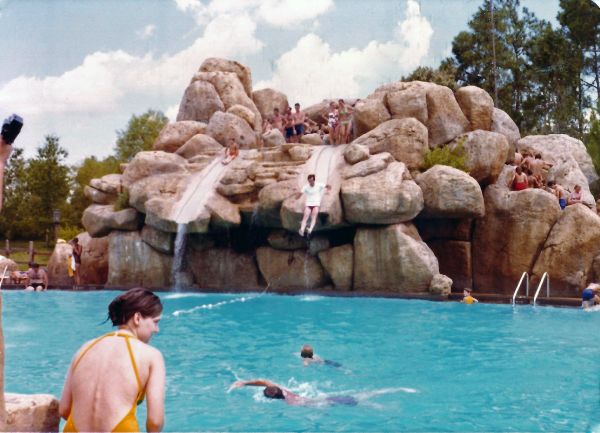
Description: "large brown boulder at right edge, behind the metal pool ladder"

(533, 204), (600, 297)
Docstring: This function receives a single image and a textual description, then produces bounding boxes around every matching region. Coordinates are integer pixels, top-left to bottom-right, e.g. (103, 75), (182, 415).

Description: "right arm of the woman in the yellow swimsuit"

(146, 349), (165, 432)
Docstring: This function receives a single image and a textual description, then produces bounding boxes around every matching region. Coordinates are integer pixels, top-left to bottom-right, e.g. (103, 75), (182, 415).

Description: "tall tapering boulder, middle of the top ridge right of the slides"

(426, 84), (470, 148)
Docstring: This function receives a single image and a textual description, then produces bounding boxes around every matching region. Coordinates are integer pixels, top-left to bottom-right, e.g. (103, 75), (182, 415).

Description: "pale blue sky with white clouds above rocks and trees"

(0, 0), (584, 164)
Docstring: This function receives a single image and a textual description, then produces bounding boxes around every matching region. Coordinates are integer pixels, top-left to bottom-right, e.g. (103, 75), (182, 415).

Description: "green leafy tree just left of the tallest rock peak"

(115, 110), (169, 162)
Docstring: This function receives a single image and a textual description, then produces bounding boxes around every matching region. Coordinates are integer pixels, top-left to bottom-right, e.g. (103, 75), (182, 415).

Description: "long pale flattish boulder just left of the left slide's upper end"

(122, 151), (187, 188)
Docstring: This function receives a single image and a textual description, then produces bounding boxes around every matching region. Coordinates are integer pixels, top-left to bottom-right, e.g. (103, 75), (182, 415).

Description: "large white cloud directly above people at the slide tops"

(256, 0), (433, 105)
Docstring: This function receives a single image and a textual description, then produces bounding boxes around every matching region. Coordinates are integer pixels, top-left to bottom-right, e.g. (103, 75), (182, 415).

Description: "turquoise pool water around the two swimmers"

(3, 292), (600, 432)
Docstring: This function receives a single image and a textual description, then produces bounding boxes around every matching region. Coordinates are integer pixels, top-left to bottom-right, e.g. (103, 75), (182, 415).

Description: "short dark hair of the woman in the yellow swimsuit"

(108, 287), (162, 326)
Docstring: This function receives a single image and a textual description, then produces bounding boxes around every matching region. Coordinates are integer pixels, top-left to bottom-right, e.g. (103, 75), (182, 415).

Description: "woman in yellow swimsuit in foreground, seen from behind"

(59, 288), (165, 432)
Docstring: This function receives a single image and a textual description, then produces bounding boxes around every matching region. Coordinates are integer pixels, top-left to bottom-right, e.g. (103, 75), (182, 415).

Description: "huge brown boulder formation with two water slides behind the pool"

(64, 58), (600, 296)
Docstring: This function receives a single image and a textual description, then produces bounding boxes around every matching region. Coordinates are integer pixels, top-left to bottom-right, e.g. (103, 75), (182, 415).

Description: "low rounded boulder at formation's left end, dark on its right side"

(81, 204), (141, 238)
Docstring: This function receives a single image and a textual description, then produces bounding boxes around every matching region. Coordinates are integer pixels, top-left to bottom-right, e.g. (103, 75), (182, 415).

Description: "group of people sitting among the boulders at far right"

(509, 152), (585, 210)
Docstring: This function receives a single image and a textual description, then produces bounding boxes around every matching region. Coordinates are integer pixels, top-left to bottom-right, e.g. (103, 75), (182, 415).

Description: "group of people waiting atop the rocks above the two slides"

(262, 99), (354, 145)
